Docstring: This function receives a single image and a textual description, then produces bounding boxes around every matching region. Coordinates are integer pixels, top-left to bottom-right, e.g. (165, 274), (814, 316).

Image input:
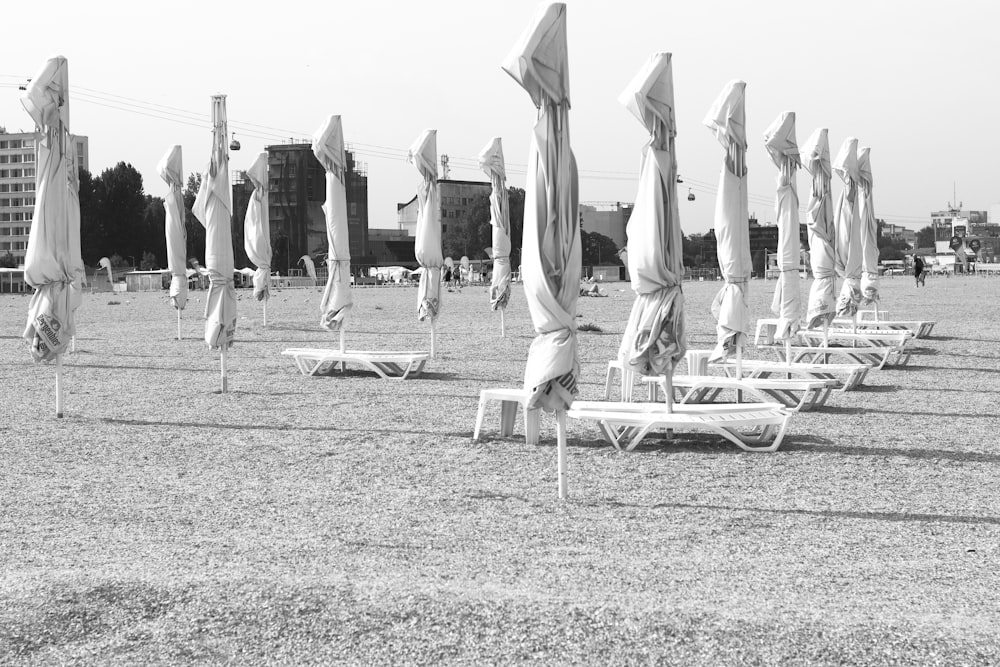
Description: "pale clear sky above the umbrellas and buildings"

(0, 0), (1000, 233)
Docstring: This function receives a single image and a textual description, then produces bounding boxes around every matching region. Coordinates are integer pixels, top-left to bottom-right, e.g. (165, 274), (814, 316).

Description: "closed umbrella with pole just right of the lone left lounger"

(407, 130), (444, 358)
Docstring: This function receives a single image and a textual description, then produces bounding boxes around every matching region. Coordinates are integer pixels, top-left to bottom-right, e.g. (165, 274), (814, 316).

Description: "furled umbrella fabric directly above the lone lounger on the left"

(312, 116), (353, 331)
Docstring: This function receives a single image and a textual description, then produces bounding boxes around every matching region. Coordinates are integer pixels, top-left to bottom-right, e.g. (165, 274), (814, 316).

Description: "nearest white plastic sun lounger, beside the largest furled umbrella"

(566, 401), (793, 452)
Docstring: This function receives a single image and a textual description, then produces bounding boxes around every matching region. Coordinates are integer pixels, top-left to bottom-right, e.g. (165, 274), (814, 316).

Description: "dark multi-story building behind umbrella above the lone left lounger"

(258, 143), (368, 274)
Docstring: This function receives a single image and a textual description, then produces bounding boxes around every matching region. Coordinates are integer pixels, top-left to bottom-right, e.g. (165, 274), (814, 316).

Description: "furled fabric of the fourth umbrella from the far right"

(764, 111), (802, 340)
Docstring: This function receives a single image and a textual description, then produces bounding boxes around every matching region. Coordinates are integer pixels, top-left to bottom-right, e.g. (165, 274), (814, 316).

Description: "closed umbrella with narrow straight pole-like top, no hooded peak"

(191, 95), (236, 393)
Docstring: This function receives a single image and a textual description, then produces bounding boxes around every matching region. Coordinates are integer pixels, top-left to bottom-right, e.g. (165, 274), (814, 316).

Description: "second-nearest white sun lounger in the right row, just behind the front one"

(640, 375), (840, 412)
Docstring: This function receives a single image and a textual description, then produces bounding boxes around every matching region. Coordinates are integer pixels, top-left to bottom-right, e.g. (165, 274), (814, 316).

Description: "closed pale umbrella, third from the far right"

(802, 127), (837, 329)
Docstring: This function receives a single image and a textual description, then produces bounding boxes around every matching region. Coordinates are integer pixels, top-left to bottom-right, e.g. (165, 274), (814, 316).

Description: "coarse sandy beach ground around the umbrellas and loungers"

(0, 277), (1000, 664)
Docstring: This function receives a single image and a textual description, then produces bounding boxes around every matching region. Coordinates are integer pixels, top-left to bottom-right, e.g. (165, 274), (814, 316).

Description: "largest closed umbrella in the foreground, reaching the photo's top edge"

(503, 3), (582, 498)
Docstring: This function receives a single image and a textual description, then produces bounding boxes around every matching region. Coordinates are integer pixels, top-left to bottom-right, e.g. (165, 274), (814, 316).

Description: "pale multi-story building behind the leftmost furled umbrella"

(0, 127), (90, 265)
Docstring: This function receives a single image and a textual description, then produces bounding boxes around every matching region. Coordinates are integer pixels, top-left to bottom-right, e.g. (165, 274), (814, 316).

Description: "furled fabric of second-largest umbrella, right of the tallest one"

(618, 53), (686, 375)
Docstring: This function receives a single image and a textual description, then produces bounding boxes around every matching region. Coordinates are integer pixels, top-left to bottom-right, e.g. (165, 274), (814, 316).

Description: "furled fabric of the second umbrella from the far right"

(833, 137), (862, 317)
